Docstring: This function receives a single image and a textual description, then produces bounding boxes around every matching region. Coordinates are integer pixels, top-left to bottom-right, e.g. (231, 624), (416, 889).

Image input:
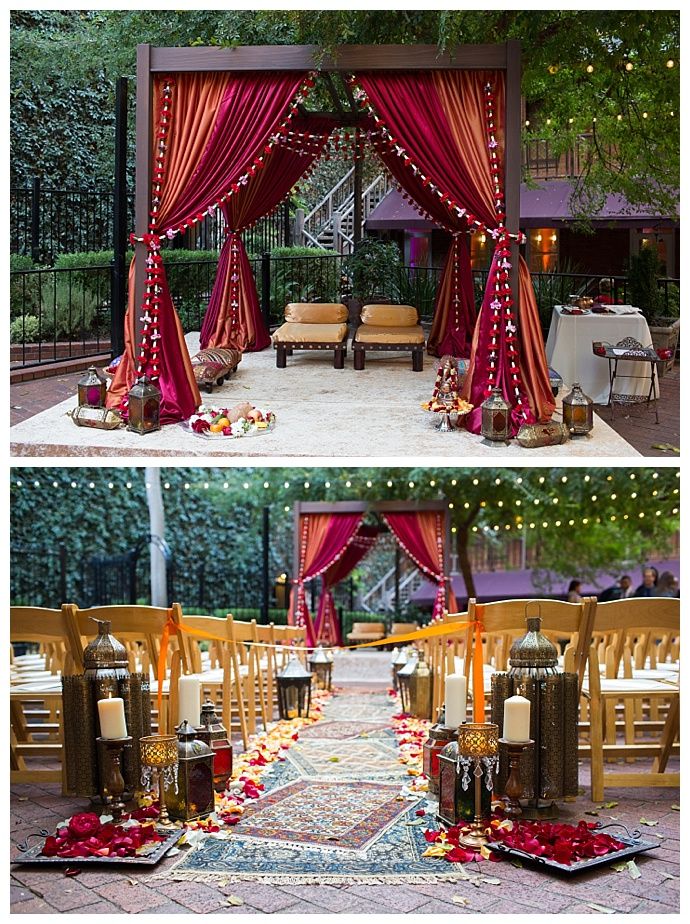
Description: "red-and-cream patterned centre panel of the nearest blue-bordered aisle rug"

(228, 780), (408, 850)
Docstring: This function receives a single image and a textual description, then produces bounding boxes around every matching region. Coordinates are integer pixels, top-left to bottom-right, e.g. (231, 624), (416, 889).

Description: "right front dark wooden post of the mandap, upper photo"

(505, 40), (522, 324)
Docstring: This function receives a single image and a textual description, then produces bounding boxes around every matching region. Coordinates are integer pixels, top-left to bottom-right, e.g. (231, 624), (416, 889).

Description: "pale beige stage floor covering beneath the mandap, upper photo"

(10, 334), (639, 464)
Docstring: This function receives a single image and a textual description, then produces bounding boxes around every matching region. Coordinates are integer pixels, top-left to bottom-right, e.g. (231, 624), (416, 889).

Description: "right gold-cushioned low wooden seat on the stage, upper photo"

(352, 305), (424, 372)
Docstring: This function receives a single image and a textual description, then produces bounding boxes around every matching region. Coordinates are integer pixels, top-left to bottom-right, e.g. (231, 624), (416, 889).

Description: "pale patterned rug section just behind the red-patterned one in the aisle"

(287, 738), (405, 780)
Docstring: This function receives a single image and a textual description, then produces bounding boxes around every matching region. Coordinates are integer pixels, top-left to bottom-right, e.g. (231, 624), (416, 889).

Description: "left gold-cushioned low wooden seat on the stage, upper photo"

(272, 302), (348, 369)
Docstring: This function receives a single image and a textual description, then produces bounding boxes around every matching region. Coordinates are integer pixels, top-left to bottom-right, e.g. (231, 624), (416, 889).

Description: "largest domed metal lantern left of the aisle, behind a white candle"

(62, 620), (151, 801)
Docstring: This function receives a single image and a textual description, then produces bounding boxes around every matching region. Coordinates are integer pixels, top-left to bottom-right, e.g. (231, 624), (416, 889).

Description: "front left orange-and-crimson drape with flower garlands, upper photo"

(108, 71), (308, 423)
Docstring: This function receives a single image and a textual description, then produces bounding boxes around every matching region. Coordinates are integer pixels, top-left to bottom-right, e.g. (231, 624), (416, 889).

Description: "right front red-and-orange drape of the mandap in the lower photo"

(383, 510), (455, 619)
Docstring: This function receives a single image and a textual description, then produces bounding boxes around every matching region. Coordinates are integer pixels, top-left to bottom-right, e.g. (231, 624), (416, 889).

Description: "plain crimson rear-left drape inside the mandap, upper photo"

(201, 116), (336, 352)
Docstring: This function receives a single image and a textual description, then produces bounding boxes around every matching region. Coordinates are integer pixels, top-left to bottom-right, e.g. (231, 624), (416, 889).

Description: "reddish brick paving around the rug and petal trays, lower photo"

(10, 684), (680, 915)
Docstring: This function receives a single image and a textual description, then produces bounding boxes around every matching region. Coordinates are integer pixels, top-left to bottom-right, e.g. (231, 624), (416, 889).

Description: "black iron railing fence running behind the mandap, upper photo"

(10, 251), (680, 367)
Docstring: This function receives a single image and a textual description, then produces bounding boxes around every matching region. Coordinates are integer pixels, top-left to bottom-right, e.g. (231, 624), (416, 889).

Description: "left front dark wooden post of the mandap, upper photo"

(133, 45), (153, 368)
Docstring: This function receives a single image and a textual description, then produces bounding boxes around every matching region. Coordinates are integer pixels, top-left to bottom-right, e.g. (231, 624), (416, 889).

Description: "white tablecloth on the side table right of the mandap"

(546, 305), (652, 404)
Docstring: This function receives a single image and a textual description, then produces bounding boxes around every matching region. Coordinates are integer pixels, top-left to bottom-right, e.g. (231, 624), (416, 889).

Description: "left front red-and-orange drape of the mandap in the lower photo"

(288, 513), (363, 645)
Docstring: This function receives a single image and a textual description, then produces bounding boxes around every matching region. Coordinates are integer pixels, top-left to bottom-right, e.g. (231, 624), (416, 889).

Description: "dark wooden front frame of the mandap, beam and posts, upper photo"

(135, 40), (522, 352)
